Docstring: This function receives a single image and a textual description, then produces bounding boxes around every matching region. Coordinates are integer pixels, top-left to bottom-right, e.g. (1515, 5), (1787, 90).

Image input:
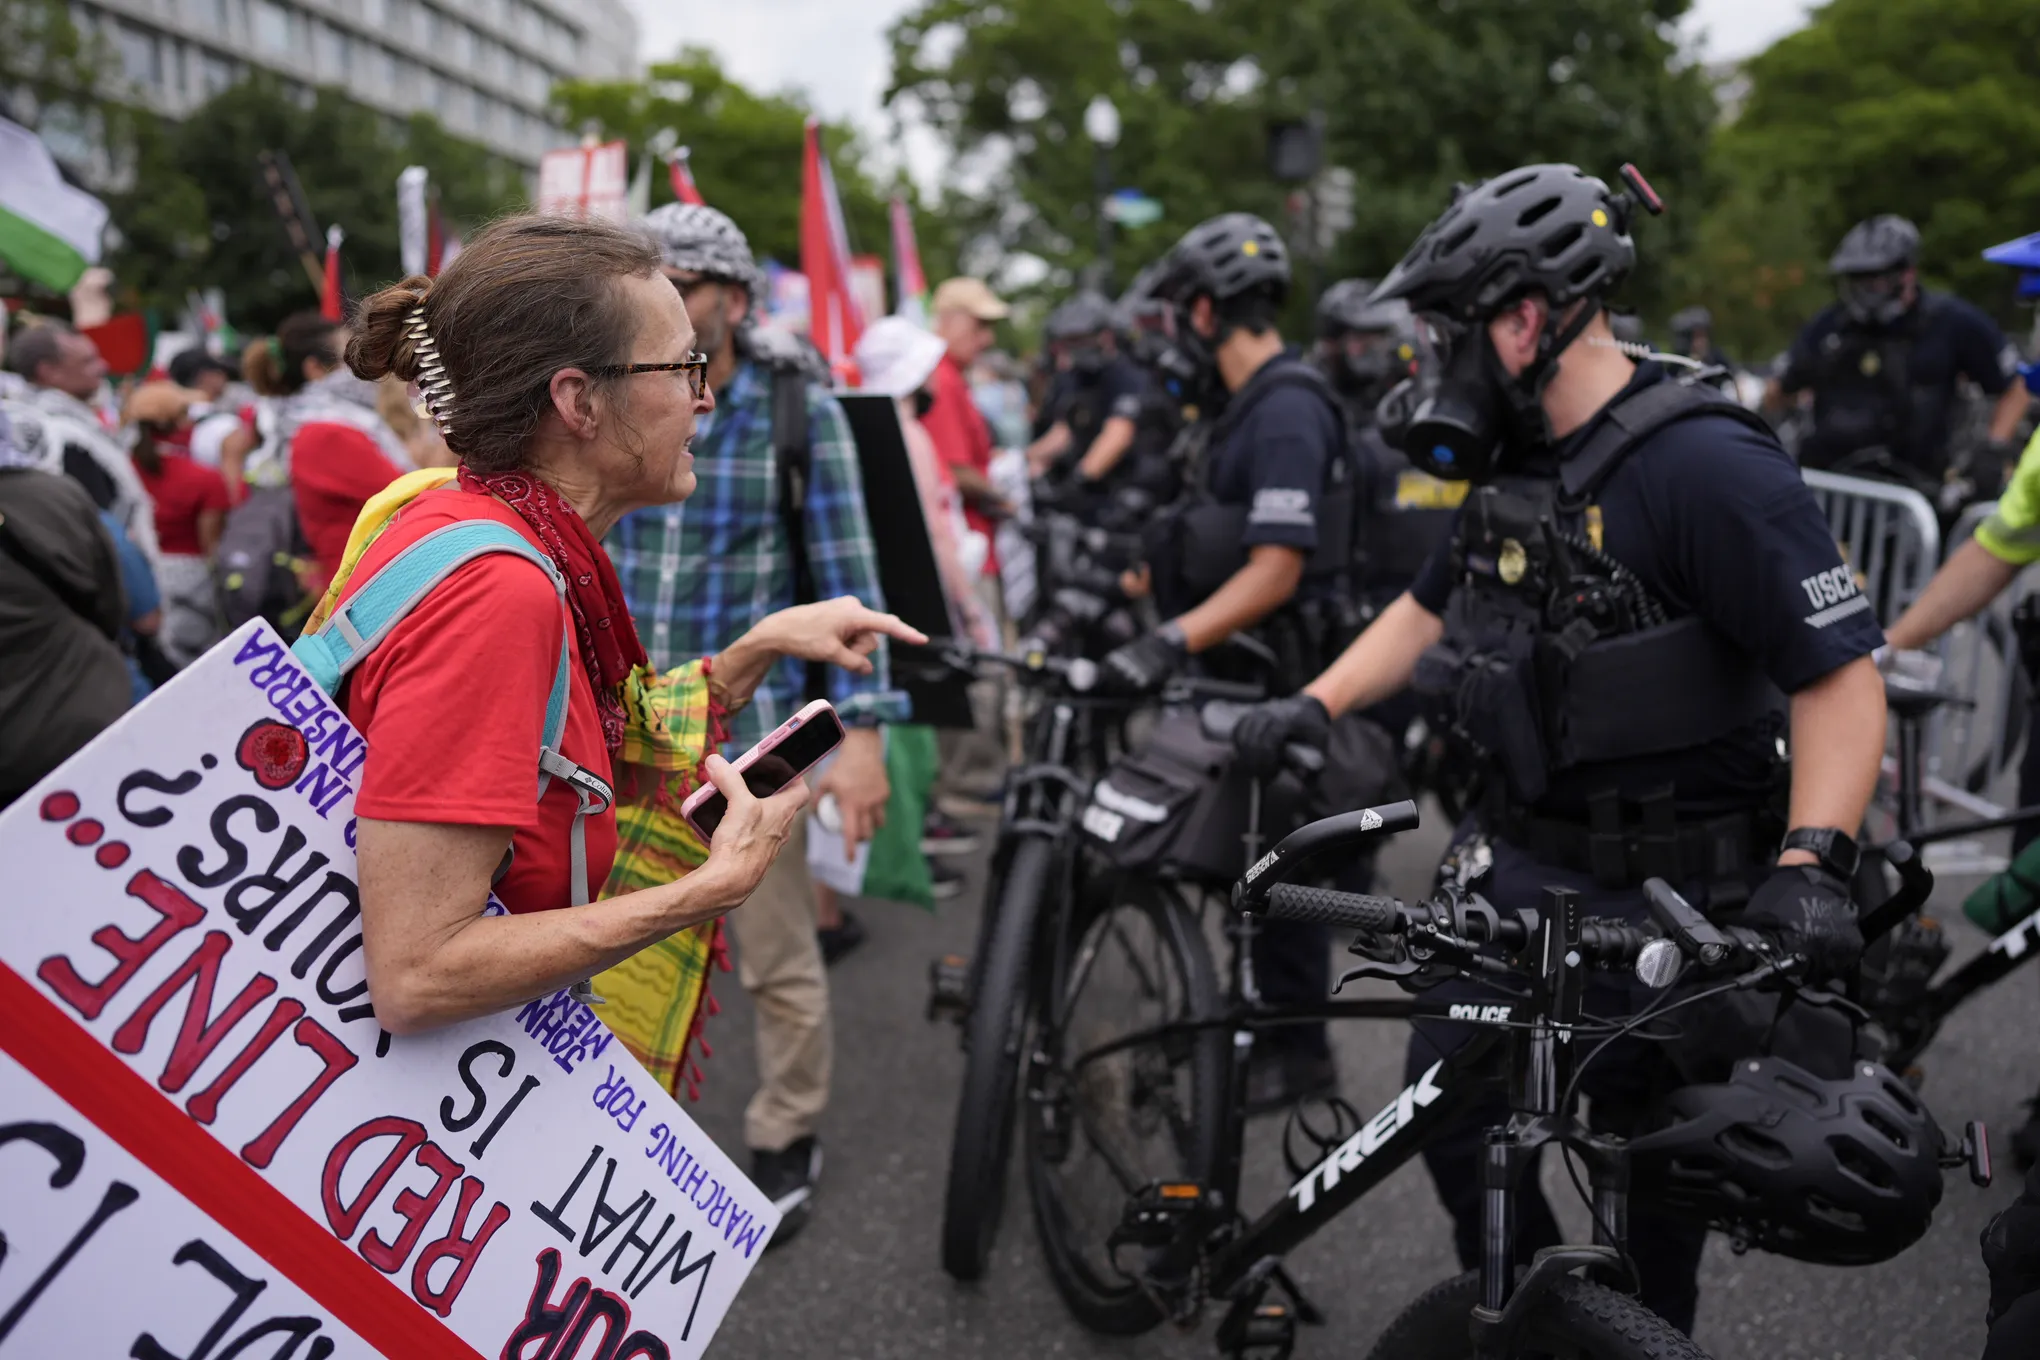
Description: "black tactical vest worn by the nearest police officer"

(1416, 381), (1783, 807)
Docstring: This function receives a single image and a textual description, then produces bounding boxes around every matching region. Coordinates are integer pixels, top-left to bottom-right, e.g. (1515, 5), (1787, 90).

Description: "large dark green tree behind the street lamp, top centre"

(889, 0), (1714, 322)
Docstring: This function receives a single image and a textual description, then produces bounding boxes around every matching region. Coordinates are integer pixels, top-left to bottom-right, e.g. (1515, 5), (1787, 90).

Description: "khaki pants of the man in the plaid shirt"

(722, 818), (834, 1152)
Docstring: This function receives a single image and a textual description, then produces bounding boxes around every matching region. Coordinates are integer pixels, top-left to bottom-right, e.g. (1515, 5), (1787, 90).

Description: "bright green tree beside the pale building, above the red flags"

(553, 47), (951, 287)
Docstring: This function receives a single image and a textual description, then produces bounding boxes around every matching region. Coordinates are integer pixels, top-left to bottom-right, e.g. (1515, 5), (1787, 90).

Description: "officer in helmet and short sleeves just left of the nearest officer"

(1102, 212), (1393, 1109)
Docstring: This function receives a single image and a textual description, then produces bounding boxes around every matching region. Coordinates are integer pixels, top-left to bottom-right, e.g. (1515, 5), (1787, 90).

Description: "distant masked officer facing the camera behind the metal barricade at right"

(1767, 214), (2026, 495)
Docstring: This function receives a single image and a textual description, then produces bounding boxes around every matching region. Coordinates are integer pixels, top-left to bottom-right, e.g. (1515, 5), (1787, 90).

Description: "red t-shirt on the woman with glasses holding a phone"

(336, 483), (616, 911)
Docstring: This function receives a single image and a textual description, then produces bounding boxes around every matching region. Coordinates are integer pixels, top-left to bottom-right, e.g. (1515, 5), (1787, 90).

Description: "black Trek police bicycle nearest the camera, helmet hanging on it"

(1028, 770), (1989, 1360)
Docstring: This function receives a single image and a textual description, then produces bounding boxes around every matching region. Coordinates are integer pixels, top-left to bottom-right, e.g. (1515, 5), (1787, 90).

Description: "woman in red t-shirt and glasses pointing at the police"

(341, 216), (926, 1034)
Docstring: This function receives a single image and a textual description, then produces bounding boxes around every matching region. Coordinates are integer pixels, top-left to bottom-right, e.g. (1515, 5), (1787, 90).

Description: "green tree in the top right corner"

(1687, 0), (2040, 349)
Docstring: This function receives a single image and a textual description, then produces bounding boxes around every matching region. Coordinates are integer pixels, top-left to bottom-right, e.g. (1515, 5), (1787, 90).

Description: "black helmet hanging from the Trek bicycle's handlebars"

(1628, 1056), (1944, 1266)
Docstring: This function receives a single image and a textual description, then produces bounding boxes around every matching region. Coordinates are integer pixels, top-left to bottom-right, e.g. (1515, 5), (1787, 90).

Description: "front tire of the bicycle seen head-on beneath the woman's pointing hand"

(942, 836), (1057, 1280)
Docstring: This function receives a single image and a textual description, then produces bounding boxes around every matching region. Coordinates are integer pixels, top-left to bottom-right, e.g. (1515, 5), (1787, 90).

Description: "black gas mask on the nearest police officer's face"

(1375, 318), (1557, 481)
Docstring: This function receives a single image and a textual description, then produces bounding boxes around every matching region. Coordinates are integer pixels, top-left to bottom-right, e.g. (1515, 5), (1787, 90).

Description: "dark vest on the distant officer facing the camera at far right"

(1805, 296), (1940, 473)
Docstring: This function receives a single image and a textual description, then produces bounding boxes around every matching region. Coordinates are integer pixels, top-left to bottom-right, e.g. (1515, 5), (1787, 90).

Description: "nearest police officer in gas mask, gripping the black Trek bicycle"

(1236, 165), (1885, 1329)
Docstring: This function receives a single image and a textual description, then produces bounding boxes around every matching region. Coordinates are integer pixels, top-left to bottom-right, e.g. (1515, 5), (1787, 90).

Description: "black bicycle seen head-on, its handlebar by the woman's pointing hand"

(924, 644), (1263, 1280)
